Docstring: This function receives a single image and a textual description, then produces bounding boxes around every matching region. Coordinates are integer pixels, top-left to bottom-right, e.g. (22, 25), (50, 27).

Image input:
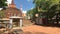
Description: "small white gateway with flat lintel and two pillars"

(10, 16), (22, 28)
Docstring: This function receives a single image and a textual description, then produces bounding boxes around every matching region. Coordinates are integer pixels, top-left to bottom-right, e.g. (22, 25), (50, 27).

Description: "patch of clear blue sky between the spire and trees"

(14, 0), (34, 11)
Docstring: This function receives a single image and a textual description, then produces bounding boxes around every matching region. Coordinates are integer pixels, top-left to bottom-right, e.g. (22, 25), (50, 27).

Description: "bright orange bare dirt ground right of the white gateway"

(22, 25), (60, 34)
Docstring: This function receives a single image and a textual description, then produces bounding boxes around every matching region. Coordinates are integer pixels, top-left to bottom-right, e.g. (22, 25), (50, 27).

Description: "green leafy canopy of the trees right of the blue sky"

(27, 0), (60, 18)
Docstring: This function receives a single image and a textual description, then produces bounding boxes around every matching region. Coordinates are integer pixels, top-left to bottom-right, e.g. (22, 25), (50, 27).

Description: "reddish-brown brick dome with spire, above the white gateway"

(3, 0), (22, 18)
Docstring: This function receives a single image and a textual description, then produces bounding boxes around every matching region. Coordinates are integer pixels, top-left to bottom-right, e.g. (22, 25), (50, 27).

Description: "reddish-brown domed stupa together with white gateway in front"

(0, 0), (22, 28)
